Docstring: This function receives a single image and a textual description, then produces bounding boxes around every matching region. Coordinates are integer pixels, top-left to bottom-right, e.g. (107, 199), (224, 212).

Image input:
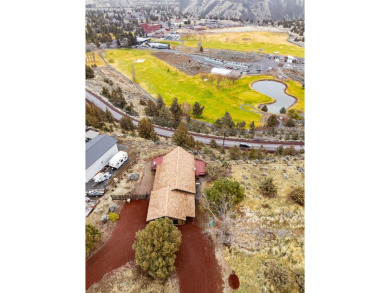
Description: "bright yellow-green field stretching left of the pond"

(106, 49), (303, 126)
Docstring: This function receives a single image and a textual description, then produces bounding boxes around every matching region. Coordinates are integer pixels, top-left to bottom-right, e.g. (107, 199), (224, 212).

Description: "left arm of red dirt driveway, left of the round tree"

(86, 200), (149, 289)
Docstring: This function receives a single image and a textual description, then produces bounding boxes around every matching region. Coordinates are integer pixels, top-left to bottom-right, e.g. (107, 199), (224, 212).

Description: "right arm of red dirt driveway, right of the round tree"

(175, 218), (223, 293)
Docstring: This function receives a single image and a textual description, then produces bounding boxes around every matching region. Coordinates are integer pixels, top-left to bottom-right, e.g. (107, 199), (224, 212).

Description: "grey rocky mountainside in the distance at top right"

(180, 0), (305, 21)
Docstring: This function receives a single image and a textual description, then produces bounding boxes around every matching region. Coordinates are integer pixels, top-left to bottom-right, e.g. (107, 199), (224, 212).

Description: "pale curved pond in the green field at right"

(252, 80), (296, 114)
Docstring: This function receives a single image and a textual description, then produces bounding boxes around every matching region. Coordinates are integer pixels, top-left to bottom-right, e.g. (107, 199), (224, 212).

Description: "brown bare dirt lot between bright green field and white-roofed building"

(153, 52), (211, 76)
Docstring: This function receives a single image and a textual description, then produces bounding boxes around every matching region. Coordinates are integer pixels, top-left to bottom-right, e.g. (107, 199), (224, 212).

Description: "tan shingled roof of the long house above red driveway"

(146, 147), (196, 225)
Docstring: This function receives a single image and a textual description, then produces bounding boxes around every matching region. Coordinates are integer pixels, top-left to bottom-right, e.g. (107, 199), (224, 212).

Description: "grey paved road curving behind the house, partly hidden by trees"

(85, 90), (304, 151)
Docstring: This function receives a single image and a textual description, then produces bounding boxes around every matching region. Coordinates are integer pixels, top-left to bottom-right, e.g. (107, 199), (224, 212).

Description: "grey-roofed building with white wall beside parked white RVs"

(85, 135), (118, 182)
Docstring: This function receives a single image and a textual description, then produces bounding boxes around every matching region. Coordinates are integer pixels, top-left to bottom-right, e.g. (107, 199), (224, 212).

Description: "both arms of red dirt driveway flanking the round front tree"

(86, 200), (222, 293)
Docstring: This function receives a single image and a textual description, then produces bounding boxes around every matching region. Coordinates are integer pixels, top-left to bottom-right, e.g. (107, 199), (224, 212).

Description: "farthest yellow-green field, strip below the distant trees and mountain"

(183, 32), (305, 57)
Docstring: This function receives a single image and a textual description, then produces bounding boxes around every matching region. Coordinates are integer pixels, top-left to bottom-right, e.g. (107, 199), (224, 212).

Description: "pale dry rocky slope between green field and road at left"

(85, 66), (149, 117)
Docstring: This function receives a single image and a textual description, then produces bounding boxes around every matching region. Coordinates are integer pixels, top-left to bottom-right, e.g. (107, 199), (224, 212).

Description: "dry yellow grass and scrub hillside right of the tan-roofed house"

(204, 158), (304, 293)
